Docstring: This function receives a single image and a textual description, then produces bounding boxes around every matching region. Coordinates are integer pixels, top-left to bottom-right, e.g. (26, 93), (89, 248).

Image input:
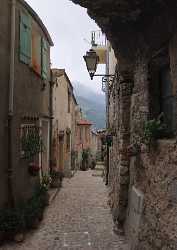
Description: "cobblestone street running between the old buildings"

(1, 171), (127, 250)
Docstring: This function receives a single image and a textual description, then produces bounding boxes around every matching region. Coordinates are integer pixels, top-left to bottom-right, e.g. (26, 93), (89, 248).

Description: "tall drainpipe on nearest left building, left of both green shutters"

(7, 0), (16, 207)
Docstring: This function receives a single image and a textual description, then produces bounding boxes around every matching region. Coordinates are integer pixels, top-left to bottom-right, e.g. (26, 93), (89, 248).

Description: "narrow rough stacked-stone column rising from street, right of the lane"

(113, 72), (133, 227)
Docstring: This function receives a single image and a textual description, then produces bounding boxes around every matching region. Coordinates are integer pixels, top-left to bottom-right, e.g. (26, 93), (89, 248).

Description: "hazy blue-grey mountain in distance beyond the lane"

(72, 82), (106, 129)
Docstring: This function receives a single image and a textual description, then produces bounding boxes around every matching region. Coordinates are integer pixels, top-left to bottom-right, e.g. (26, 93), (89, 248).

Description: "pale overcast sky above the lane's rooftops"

(26, 0), (102, 92)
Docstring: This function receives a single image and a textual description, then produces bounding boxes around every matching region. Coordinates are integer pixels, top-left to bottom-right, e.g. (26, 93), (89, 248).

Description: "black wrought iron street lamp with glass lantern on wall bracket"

(84, 49), (114, 92)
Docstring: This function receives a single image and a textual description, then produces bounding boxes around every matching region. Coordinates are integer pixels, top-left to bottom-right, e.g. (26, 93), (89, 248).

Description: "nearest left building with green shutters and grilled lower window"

(0, 0), (53, 207)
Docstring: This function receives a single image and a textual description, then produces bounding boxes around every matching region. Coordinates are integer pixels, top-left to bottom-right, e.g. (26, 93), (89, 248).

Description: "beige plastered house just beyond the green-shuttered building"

(52, 69), (78, 177)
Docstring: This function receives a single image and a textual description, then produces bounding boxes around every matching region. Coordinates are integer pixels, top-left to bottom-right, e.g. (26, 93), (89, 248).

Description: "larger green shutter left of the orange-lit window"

(20, 13), (32, 64)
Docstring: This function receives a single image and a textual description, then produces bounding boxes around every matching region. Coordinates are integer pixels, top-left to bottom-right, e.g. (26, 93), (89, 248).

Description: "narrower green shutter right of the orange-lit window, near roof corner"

(41, 38), (49, 79)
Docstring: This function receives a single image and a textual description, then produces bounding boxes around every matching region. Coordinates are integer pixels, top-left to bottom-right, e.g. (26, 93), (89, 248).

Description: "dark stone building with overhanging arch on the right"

(73, 0), (177, 250)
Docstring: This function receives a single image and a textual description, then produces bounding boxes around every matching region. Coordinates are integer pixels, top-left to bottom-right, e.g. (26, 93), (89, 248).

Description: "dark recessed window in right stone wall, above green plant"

(149, 48), (176, 138)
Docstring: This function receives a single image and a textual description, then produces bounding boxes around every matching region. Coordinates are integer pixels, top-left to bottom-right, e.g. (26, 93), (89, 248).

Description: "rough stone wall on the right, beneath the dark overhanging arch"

(109, 39), (177, 250)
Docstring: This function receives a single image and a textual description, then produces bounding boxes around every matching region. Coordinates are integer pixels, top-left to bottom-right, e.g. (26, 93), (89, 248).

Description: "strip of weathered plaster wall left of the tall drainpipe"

(0, 0), (10, 207)
